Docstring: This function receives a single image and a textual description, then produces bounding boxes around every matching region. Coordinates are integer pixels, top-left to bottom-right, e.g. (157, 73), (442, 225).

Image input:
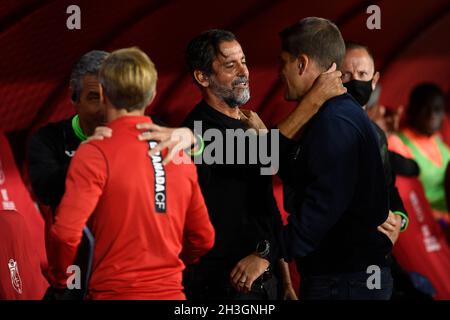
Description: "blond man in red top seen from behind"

(47, 48), (214, 299)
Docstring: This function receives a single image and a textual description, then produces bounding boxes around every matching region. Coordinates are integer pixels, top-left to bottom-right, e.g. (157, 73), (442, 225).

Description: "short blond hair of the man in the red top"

(99, 47), (158, 111)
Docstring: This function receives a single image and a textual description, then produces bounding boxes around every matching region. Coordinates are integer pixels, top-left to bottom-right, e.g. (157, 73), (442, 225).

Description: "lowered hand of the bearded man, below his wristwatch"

(230, 254), (270, 293)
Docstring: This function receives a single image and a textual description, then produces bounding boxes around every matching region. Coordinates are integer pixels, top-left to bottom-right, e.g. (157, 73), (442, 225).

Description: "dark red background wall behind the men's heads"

(0, 0), (450, 136)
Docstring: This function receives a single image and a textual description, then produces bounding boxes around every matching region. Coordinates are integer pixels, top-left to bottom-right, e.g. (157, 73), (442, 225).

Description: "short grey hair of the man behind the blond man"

(70, 50), (109, 102)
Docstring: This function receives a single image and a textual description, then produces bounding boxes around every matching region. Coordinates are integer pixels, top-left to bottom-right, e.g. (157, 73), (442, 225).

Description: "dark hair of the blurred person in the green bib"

(406, 82), (444, 125)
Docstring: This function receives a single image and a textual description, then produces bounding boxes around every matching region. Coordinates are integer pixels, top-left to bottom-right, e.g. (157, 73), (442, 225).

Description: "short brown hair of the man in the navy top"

(280, 17), (345, 70)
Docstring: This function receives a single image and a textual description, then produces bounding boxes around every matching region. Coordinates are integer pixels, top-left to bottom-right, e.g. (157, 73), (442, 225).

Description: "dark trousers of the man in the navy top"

(299, 268), (393, 300)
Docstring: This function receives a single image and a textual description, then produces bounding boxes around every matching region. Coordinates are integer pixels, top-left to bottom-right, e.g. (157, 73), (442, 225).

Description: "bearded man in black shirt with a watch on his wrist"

(180, 29), (345, 300)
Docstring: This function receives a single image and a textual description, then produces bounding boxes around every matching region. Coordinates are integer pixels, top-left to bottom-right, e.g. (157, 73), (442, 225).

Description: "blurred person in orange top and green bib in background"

(389, 83), (450, 228)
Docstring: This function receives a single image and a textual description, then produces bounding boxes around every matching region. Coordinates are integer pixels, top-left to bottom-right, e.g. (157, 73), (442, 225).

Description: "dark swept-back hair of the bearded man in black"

(186, 29), (236, 75)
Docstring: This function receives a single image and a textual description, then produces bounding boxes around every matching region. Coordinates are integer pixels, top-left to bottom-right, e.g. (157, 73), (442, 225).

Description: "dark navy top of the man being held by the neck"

(280, 94), (392, 275)
